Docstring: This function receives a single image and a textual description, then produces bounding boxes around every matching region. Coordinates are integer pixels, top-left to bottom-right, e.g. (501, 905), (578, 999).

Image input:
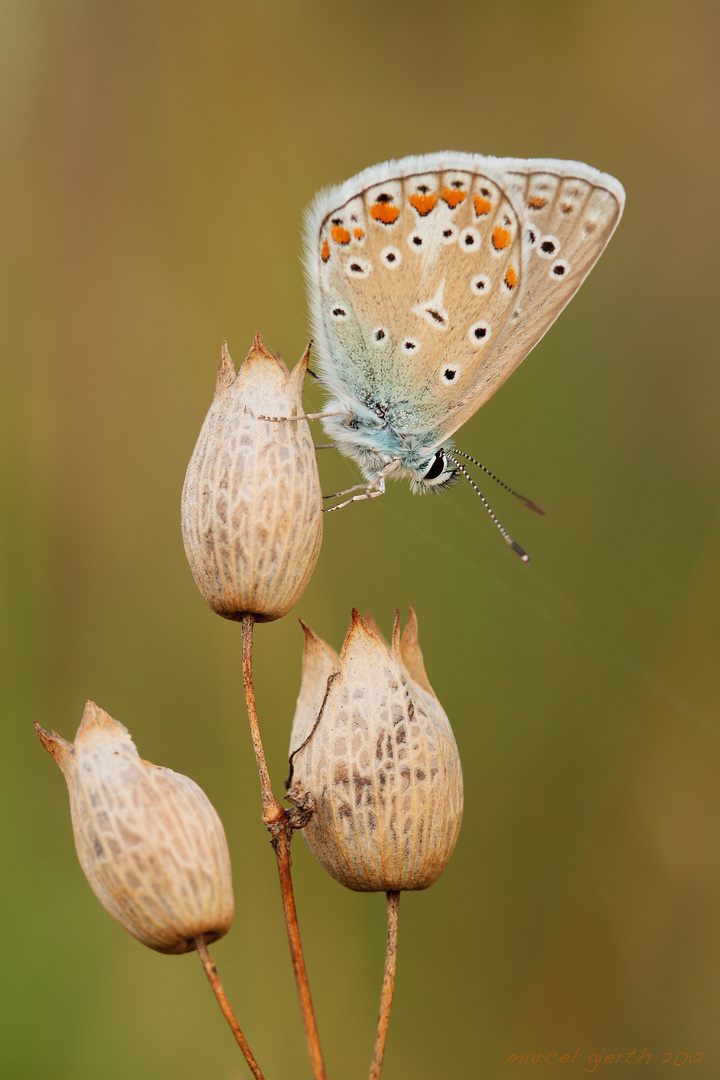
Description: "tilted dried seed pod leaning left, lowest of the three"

(35, 701), (234, 954)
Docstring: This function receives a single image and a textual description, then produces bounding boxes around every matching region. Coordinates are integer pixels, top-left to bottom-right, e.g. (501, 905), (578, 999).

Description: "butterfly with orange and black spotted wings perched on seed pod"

(304, 152), (625, 557)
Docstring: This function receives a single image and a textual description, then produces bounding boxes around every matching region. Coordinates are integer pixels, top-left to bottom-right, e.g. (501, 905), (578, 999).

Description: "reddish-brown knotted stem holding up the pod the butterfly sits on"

(243, 615), (327, 1080)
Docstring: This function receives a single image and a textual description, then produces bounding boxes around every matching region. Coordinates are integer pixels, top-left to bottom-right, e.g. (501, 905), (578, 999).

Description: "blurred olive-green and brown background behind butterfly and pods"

(0, 0), (720, 1080)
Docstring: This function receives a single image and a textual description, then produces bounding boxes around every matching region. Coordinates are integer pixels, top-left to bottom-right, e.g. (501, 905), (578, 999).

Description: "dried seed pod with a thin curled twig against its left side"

(287, 609), (463, 891)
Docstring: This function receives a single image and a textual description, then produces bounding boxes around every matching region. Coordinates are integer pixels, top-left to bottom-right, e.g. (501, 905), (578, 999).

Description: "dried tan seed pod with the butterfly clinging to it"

(182, 334), (323, 622)
